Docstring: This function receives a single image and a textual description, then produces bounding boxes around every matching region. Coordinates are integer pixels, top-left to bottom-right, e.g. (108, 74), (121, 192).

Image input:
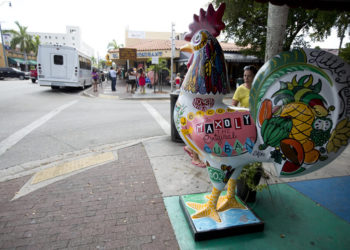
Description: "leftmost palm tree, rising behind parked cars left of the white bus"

(4, 21), (33, 71)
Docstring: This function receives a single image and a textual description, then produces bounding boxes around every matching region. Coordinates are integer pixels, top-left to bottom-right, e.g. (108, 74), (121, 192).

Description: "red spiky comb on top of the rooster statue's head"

(185, 3), (226, 41)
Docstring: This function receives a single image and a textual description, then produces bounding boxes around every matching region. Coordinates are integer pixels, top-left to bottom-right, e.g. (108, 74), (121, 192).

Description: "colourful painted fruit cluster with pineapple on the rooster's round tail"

(259, 74), (334, 175)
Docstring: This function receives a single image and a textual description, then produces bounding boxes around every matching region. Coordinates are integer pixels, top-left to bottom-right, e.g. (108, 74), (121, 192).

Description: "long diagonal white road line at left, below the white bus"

(0, 100), (78, 156)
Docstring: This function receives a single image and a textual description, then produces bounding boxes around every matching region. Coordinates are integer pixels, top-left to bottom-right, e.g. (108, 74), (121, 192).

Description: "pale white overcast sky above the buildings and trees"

(0, 0), (349, 58)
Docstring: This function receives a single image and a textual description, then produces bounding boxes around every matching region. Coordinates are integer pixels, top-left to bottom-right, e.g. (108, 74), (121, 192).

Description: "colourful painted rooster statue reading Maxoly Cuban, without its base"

(174, 4), (350, 223)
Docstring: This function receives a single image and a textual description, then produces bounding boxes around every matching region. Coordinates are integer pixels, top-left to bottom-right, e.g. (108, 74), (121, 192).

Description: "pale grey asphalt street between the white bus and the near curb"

(0, 80), (170, 170)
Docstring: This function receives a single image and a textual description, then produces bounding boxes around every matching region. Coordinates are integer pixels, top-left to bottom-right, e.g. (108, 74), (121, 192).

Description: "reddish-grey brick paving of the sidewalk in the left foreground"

(0, 144), (179, 249)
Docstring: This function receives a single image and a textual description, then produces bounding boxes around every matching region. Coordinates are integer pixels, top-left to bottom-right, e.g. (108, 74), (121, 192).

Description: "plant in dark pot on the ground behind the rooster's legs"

(236, 162), (267, 202)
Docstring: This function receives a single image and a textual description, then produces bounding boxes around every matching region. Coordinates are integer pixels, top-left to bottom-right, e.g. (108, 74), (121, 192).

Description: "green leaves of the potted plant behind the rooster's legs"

(238, 162), (267, 191)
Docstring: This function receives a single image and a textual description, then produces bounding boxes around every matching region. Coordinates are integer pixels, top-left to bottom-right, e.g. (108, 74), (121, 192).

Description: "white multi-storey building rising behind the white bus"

(28, 26), (95, 56)
